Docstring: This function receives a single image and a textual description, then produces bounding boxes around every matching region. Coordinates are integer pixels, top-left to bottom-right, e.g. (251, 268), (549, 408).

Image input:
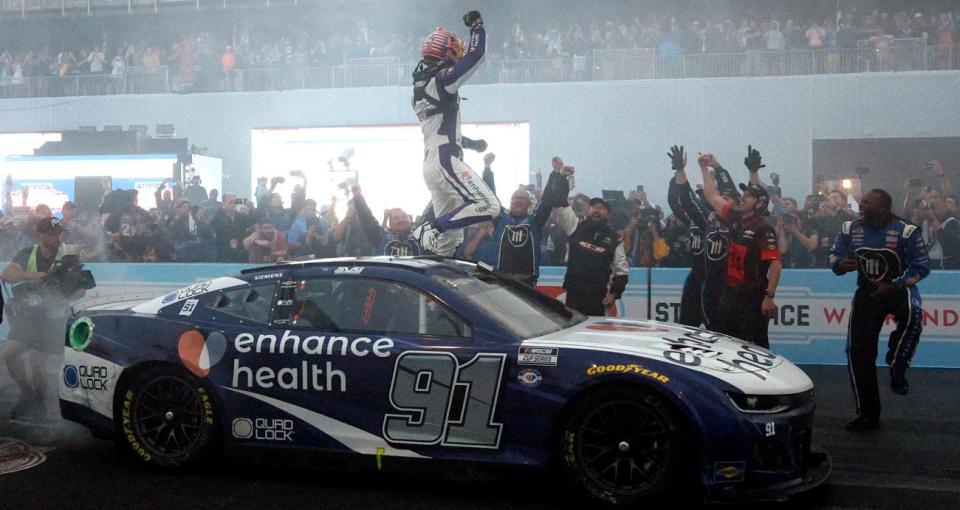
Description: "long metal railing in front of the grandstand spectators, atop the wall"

(0, 45), (960, 98)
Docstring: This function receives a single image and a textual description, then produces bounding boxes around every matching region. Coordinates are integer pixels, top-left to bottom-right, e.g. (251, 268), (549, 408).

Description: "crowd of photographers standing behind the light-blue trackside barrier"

(0, 156), (960, 268)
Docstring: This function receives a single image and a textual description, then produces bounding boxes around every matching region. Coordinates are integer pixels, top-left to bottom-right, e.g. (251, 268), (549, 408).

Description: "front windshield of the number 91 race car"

(434, 272), (586, 338)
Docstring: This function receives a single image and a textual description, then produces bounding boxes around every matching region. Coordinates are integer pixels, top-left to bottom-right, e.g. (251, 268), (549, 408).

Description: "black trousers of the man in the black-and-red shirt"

(712, 287), (770, 349)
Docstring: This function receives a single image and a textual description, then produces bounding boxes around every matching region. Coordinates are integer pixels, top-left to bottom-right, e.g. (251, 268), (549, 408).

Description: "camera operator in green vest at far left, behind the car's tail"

(0, 218), (84, 419)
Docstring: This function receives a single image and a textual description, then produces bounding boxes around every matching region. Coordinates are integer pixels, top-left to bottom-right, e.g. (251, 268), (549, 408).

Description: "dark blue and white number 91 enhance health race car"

(60, 257), (830, 505)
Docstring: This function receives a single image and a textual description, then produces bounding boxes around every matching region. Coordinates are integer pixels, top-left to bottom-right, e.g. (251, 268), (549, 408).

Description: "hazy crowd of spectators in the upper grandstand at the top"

(0, 3), (960, 85)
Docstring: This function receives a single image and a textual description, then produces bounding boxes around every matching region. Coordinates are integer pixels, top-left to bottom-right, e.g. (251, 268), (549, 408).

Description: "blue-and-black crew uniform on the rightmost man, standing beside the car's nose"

(830, 218), (930, 420)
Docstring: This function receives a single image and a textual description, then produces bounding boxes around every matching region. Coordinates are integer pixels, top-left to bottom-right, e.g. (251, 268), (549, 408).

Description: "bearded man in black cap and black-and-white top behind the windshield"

(563, 198), (629, 316)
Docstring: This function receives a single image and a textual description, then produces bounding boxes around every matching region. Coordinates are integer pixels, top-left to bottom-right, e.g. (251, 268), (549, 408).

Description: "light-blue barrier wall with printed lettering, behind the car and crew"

(0, 264), (960, 368)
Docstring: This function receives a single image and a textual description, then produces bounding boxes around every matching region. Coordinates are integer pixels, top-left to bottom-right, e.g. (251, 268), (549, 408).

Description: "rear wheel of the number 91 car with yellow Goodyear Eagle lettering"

(114, 366), (220, 468)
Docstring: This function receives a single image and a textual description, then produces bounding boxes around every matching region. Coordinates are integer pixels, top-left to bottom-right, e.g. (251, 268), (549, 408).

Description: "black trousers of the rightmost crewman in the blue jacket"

(847, 284), (923, 419)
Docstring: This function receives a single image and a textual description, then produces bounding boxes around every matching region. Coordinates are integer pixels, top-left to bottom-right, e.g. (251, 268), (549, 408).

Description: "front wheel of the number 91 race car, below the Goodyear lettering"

(559, 387), (690, 506)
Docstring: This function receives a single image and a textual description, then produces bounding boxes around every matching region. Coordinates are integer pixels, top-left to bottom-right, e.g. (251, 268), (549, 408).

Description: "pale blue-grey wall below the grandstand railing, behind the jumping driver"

(0, 71), (960, 204)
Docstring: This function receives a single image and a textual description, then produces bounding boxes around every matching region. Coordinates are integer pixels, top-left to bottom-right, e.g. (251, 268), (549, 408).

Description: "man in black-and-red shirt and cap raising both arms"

(698, 148), (782, 348)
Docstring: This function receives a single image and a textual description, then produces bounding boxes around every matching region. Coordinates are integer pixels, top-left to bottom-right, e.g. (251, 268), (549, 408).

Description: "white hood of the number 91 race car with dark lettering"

(522, 317), (813, 395)
